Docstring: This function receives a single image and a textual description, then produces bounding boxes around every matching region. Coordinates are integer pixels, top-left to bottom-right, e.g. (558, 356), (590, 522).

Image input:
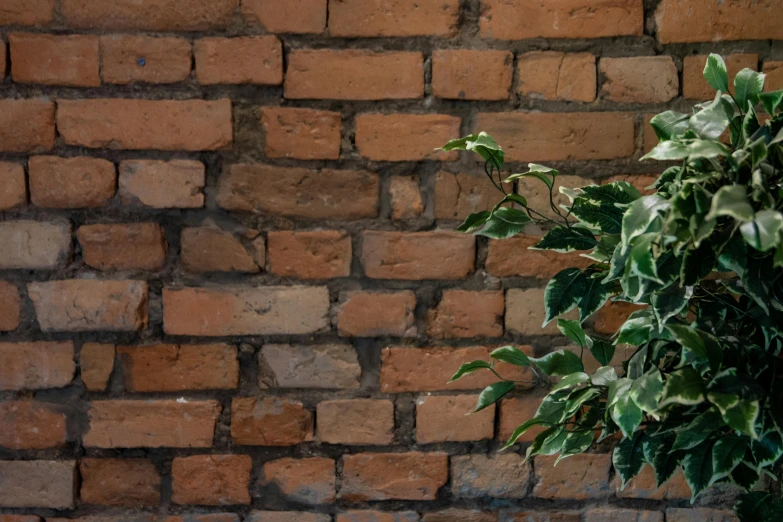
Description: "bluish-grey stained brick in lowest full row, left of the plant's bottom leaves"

(451, 453), (530, 498)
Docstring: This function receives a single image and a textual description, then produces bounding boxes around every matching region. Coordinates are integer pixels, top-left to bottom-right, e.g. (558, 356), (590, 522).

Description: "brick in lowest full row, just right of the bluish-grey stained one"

(533, 454), (612, 500)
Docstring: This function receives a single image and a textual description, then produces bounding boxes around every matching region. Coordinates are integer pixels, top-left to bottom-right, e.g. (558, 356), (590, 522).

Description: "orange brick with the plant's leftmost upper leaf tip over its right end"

(356, 114), (461, 161)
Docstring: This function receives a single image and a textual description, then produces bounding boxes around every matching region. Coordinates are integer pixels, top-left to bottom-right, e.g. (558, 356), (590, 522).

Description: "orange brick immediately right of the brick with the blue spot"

(193, 36), (283, 85)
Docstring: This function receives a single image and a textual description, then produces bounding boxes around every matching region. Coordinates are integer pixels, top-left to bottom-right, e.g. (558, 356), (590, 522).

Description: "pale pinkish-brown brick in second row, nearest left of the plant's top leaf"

(599, 56), (680, 103)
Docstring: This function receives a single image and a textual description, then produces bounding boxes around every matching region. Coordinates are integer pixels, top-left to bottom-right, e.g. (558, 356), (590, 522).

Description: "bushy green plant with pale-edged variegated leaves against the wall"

(443, 55), (783, 522)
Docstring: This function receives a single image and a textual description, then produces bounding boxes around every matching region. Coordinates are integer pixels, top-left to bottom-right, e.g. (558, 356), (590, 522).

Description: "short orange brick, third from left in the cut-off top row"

(242, 0), (327, 34)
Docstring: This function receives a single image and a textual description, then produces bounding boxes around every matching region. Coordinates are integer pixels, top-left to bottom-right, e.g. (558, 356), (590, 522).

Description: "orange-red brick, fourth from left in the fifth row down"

(269, 230), (351, 279)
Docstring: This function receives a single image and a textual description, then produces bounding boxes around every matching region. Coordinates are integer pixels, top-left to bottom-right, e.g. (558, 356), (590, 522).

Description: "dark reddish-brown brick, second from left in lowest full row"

(79, 459), (160, 506)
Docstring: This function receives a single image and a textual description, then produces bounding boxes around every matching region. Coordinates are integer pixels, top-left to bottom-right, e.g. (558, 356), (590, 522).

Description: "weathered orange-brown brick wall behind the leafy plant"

(0, 0), (783, 522)
